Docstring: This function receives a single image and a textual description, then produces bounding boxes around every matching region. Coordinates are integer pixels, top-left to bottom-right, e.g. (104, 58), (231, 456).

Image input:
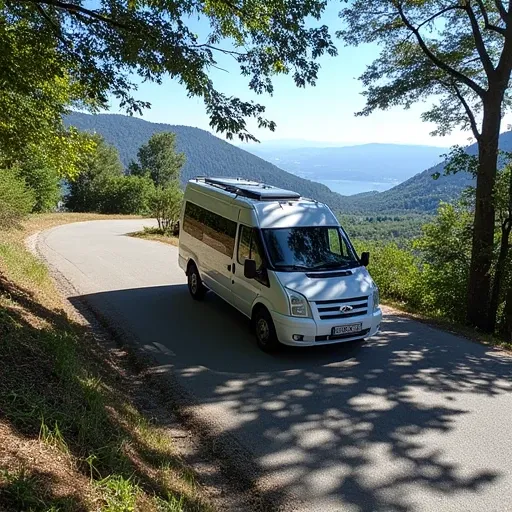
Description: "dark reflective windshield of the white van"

(262, 226), (360, 271)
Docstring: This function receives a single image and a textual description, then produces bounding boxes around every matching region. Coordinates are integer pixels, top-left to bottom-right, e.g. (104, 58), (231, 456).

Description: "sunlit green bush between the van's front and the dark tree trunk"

(356, 204), (472, 321)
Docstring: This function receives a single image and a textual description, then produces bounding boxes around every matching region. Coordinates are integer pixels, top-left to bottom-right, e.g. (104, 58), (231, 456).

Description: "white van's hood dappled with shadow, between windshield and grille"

(276, 267), (375, 301)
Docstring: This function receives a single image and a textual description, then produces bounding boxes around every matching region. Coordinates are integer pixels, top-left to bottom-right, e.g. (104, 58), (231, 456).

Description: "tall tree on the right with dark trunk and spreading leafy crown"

(339, 0), (512, 331)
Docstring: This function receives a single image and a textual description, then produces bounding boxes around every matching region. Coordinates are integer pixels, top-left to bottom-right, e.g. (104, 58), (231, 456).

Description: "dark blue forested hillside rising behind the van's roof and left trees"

(65, 113), (343, 208)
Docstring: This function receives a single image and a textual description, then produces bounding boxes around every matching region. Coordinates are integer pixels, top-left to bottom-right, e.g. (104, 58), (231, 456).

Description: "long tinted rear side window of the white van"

(183, 201), (236, 257)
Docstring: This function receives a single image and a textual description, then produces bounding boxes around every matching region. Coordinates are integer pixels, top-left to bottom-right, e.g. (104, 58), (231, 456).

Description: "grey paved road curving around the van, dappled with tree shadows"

(40, 221), (512, 512)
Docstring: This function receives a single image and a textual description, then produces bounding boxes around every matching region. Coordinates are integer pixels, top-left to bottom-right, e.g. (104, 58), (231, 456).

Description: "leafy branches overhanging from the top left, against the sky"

(0, 0), (336, 139)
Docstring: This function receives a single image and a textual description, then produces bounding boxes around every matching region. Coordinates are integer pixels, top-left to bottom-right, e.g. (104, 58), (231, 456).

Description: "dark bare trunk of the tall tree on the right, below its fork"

(467, 94), (503, 332)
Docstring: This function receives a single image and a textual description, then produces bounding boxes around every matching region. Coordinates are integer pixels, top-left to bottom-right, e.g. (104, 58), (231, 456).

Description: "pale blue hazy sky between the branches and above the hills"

(111, 2), (506, 146)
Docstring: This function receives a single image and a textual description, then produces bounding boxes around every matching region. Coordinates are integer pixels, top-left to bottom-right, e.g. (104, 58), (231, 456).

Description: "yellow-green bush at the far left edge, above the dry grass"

(0, 169), (36, 229)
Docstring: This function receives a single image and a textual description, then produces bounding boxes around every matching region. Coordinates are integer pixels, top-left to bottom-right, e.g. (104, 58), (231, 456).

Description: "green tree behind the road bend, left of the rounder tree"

(66, 135), (123, 212)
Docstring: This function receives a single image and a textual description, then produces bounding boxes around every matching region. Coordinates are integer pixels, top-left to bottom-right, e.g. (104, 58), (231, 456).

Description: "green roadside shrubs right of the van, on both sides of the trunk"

(350, 177), (512, 348)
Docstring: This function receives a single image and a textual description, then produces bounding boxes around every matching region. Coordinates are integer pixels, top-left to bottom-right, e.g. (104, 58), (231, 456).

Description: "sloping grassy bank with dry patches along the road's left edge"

(0, 214), (211, 512)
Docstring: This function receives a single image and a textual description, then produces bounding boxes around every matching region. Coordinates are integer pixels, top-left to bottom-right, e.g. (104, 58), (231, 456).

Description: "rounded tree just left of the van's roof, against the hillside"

(130, 132), (185, 187)
